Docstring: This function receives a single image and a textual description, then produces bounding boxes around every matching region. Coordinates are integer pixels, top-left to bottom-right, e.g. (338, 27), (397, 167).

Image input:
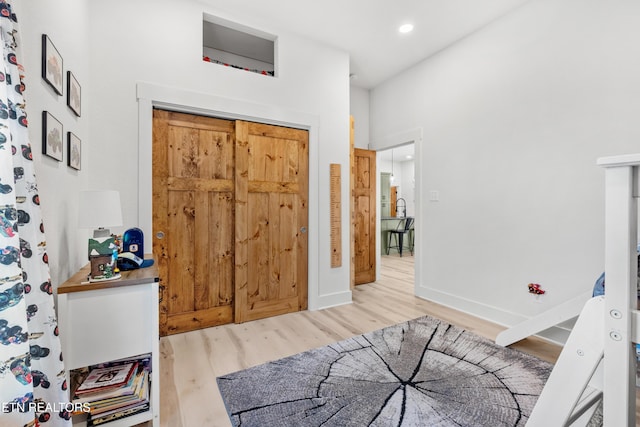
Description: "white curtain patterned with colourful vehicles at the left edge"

(0, 0), (71, 426)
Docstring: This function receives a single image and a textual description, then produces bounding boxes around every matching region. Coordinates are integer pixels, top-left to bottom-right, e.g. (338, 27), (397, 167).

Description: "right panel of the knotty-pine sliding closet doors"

(235, 121), (309, 323)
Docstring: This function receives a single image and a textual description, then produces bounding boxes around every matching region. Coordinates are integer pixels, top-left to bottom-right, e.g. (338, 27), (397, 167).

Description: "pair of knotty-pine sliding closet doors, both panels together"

(152, 110), (308, 335)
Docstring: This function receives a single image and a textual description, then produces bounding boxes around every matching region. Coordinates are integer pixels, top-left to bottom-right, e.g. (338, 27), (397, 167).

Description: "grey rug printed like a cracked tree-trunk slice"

(217, 317), (553, 427)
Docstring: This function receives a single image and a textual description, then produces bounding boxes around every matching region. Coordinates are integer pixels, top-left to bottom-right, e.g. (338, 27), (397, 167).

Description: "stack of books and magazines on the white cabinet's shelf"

(73, 355), (151, 426)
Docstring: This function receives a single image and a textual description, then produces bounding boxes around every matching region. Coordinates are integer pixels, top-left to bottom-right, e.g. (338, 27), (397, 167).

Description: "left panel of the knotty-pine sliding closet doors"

(152, 110), (235, 335)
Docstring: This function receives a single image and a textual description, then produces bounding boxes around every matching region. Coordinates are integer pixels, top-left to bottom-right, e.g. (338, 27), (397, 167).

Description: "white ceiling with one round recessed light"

(204, 0), (529, 88)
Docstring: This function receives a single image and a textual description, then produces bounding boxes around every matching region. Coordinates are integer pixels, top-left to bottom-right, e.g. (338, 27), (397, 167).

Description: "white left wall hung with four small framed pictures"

(11, 0), (93, 286)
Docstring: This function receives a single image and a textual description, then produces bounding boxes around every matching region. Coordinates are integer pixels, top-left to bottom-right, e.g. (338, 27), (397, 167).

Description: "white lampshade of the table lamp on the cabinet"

(78, 190), (122, 237)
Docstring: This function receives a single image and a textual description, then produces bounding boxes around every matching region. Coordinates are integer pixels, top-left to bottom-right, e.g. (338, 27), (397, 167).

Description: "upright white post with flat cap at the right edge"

(598, 154), (640, 427)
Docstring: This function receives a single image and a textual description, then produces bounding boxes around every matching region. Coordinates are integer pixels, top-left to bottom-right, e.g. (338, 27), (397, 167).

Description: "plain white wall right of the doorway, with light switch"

(370, 0), (640, 342)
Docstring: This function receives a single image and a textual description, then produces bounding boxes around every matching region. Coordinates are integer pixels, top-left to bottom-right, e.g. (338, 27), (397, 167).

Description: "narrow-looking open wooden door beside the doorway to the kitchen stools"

(352, 148), (376, 285)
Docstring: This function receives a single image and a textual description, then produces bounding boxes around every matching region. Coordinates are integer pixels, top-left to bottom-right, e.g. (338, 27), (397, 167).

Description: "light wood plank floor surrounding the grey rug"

(160, 255), (572, 427)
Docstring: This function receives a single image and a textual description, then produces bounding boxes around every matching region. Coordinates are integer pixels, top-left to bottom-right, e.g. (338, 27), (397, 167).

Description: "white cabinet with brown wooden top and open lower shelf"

(58, 264), (160, 427)
